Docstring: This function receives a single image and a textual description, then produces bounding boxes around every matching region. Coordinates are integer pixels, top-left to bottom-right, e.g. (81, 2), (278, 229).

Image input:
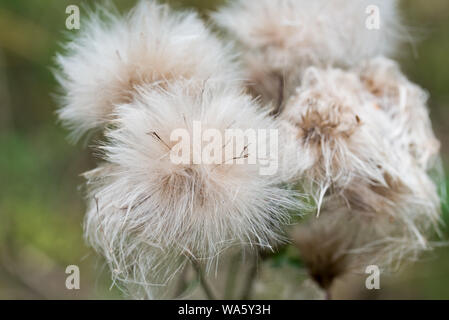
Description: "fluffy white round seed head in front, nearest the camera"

(86, 82), (297, 295)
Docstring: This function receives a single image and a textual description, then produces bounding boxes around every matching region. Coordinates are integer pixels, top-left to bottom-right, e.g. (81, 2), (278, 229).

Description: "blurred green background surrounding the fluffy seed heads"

(0, 0), (449, 299)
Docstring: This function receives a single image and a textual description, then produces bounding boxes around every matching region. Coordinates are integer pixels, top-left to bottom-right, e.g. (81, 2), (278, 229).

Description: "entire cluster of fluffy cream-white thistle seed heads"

(56, 0), (442, 298)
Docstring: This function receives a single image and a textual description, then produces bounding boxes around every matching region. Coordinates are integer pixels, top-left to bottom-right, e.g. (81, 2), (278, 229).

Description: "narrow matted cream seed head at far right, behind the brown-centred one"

(356, 57), (440, 170)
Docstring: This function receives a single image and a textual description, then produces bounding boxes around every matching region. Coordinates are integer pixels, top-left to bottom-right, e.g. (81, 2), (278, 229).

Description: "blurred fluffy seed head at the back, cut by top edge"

(213, 0), (404, 103)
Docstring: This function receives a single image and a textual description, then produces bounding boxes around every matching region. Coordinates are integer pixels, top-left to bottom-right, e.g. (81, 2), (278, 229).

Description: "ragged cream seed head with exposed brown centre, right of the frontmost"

(281, 67), (400, 208)
